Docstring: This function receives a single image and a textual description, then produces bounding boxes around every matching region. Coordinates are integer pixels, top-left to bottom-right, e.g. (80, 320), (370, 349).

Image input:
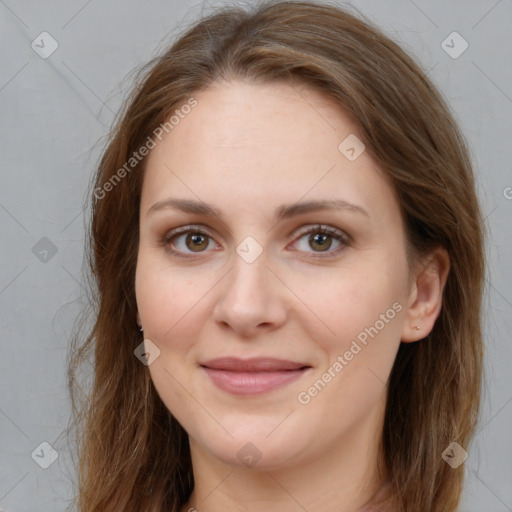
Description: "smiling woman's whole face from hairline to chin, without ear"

(136, 82), (408, 468)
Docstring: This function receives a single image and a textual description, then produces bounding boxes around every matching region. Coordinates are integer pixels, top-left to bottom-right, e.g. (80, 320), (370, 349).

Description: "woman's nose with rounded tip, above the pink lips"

(213, 249), (289, 337)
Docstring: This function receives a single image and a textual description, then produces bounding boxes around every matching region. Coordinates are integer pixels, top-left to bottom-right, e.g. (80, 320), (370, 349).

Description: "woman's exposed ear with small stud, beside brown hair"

(402, 247), (450, 343)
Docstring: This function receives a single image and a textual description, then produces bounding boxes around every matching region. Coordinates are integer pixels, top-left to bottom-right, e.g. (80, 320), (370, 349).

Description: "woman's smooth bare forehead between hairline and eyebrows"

(142, 82), (398, 228)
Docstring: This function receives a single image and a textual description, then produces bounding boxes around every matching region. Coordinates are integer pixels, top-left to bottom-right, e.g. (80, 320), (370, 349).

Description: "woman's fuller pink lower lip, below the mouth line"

(202, 366), (310, 395)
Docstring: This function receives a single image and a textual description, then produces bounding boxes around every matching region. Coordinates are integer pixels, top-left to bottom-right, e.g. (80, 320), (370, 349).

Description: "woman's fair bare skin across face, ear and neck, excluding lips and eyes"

(136, 81), (449, 512)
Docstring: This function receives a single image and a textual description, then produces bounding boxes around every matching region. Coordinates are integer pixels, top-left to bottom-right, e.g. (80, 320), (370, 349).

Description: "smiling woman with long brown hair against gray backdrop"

(70, 2), (484, 512)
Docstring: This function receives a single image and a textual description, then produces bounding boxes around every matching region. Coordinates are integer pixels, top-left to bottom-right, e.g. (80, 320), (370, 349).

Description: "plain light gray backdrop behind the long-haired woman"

(0, 0), (512, 512)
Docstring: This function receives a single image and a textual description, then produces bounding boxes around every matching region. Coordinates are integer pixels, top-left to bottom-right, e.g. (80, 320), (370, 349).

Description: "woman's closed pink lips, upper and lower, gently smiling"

(200, 357), (311, 395)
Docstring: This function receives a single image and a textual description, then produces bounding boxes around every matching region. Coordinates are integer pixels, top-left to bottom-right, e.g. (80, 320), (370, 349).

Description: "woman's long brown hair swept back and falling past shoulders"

(69, 1), (484, 512)
